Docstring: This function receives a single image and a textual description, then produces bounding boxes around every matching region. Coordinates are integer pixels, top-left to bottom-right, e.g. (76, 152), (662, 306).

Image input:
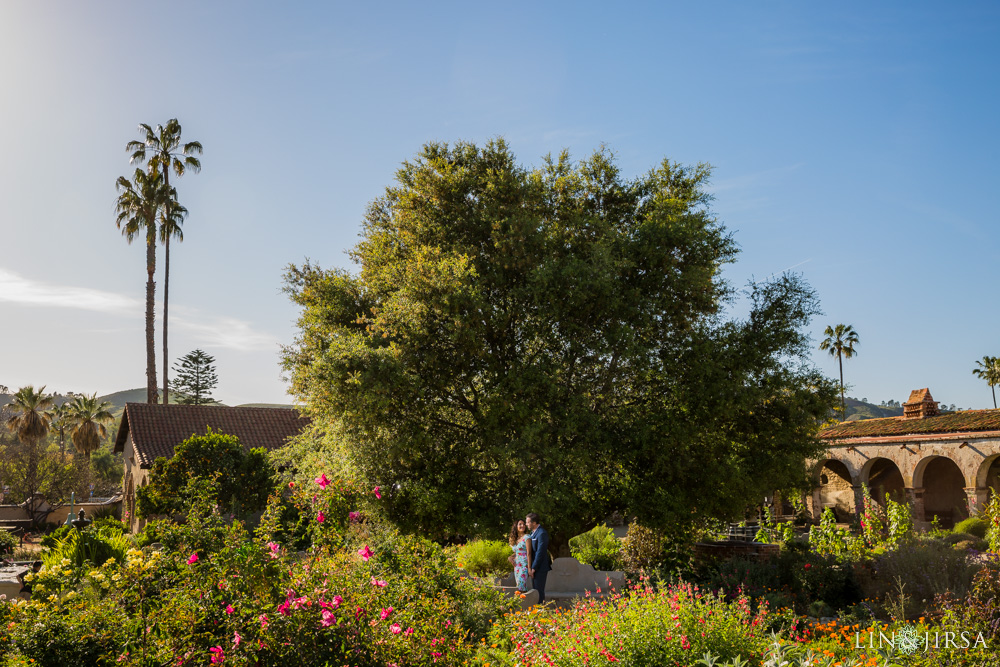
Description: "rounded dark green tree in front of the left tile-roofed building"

(136, 428), (274, 517)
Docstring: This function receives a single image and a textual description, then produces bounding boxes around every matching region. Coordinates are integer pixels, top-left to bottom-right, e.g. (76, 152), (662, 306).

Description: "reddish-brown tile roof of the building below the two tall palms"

(115, 403), (309, 468)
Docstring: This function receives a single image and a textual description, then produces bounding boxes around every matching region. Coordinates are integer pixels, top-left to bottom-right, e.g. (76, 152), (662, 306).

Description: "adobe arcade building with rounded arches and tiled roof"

(808, 389), (1000, 527)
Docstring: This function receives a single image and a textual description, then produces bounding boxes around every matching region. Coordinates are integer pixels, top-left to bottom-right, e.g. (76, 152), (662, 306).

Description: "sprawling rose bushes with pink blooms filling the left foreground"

(0, 475), (513, 667)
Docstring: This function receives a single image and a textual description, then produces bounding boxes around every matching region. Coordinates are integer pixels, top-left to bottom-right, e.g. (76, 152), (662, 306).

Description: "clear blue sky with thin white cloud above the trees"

(0, 1), (1000, 408)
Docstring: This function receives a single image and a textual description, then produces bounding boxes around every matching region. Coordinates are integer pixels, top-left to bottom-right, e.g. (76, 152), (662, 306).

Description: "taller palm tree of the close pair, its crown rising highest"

(125, 118), (201, 405)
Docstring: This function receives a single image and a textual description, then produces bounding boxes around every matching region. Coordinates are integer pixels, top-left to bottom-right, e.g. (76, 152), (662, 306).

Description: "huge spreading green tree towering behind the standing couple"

(283, 141), (836, 550)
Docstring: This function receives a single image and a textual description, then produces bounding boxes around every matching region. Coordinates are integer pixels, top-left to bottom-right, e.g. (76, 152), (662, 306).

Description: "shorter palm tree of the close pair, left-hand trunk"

(115, 169), (176, 403)
